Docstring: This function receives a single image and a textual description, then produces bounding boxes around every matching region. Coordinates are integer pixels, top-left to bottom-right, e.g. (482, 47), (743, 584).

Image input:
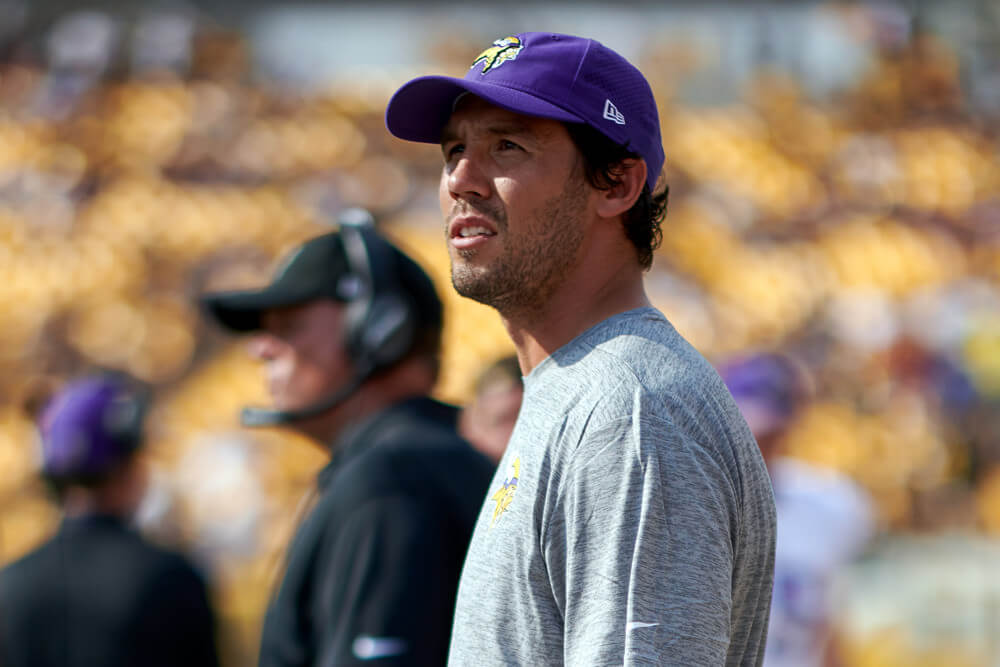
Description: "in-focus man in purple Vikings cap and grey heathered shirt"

(386, 33), (775, 665)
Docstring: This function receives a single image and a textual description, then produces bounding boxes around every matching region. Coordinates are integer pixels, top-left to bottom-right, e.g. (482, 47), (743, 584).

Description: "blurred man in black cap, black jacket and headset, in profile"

(203, 209), (492, 667)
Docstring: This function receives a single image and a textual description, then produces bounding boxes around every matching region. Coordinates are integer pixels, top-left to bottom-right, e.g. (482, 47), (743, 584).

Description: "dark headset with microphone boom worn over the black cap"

(240, 208), (417, 426)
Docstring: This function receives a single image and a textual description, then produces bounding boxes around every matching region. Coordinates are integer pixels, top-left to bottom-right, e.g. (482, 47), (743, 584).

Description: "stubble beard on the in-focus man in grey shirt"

(451, 178), (585, 319)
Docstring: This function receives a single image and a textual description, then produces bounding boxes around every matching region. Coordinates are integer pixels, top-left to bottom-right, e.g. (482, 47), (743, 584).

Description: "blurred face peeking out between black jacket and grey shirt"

(459, 382), (524, 463)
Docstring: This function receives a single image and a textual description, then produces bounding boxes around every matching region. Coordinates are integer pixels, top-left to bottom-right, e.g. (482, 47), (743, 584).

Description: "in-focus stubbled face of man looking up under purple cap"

(438, 95), (595, 313)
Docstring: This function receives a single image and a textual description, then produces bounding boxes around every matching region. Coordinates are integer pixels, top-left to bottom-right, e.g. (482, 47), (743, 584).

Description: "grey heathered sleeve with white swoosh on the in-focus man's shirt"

(543, 416), (737, 665)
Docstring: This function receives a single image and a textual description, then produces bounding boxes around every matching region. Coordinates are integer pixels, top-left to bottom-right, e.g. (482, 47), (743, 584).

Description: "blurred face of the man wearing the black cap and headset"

(250, 299), (352, 410)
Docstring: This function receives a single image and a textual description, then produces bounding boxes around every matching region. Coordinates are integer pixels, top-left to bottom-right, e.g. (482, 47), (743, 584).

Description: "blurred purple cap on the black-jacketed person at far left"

(39, 377), (143, 479)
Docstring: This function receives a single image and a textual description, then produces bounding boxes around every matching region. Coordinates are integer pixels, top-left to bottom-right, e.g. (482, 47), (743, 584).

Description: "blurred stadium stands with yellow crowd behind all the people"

(0, 0), (1000, 666)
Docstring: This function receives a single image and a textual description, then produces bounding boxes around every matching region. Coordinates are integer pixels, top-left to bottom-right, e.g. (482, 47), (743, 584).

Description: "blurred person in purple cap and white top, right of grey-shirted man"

(721, 353), (873, 667)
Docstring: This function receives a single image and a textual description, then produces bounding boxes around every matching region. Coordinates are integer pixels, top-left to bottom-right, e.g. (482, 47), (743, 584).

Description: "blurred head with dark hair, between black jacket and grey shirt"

(458, 354), (524, 463)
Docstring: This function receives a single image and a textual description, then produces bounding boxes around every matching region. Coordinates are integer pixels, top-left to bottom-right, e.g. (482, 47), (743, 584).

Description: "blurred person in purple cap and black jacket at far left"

(0, 377), (218, 667)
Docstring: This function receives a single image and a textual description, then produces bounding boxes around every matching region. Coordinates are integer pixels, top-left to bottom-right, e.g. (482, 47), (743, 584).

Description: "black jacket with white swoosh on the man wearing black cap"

(260, 398), (493, 667)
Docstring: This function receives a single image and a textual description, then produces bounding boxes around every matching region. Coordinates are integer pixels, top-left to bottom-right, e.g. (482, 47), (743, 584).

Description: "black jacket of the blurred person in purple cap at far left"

(0, 516), (218, 667)
